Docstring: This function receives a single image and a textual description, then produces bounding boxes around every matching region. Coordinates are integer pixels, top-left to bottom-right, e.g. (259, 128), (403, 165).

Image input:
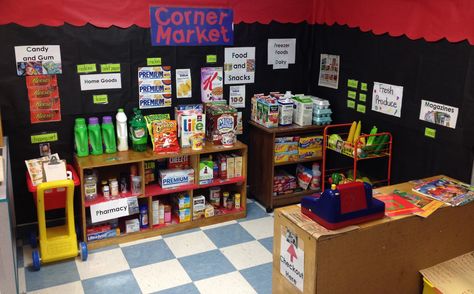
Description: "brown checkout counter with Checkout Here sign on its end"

(272, 177), (474, 294)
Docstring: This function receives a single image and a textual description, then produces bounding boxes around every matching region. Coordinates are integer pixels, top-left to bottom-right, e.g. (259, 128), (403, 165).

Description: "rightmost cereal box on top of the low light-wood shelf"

(206, 104), (237, 145)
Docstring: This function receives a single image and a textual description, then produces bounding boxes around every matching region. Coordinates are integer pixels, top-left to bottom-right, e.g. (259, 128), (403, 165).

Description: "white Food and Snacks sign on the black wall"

(224, 47), (255, 84)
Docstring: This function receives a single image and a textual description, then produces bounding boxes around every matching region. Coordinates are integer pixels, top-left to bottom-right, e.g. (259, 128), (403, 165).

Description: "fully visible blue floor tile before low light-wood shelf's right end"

(203, 224), (255, 248)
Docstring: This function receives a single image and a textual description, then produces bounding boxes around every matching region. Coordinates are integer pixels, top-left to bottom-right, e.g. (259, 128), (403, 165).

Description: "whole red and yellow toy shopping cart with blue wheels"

(27, 165), (87, 270)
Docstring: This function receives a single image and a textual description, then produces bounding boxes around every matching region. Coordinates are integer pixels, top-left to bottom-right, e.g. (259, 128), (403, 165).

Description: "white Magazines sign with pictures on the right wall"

(420, 100), (459, 129)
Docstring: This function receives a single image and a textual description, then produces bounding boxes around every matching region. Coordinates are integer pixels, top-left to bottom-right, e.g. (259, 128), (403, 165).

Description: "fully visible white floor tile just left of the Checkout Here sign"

(221, 241), (272, 270)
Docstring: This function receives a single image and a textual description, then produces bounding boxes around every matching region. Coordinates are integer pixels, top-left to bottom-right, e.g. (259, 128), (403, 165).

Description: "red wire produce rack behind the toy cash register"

(321, 123), (393, 190)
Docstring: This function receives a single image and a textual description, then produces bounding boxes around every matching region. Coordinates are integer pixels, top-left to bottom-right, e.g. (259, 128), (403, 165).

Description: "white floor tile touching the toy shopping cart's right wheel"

(76, 248), (130, 280)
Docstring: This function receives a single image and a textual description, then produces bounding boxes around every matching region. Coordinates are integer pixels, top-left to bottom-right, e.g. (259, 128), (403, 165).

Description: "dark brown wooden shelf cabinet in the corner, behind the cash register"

(248, 121), (324, 212)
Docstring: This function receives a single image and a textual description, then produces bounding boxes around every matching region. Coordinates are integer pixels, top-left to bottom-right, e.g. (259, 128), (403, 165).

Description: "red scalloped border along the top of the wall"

(0, 0), (474, 44)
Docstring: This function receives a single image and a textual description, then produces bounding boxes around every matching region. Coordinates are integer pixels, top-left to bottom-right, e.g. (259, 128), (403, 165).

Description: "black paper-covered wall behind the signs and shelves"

(0, 22), (474, 224)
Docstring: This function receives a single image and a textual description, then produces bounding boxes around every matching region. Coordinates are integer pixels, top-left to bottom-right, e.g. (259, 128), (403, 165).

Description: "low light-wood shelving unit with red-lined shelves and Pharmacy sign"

(74, 142), (247, 249)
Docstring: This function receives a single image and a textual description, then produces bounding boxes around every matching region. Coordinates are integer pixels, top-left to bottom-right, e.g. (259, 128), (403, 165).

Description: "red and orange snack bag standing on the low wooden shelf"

(152, 119), (179, 153)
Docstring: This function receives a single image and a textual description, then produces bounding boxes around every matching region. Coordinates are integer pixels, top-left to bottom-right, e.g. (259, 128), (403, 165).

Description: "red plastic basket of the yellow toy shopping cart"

(26, 164), (81, 210)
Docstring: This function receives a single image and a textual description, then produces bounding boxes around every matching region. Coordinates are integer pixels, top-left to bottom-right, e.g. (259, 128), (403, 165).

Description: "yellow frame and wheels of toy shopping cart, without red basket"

(32, 180), (87, 270)
